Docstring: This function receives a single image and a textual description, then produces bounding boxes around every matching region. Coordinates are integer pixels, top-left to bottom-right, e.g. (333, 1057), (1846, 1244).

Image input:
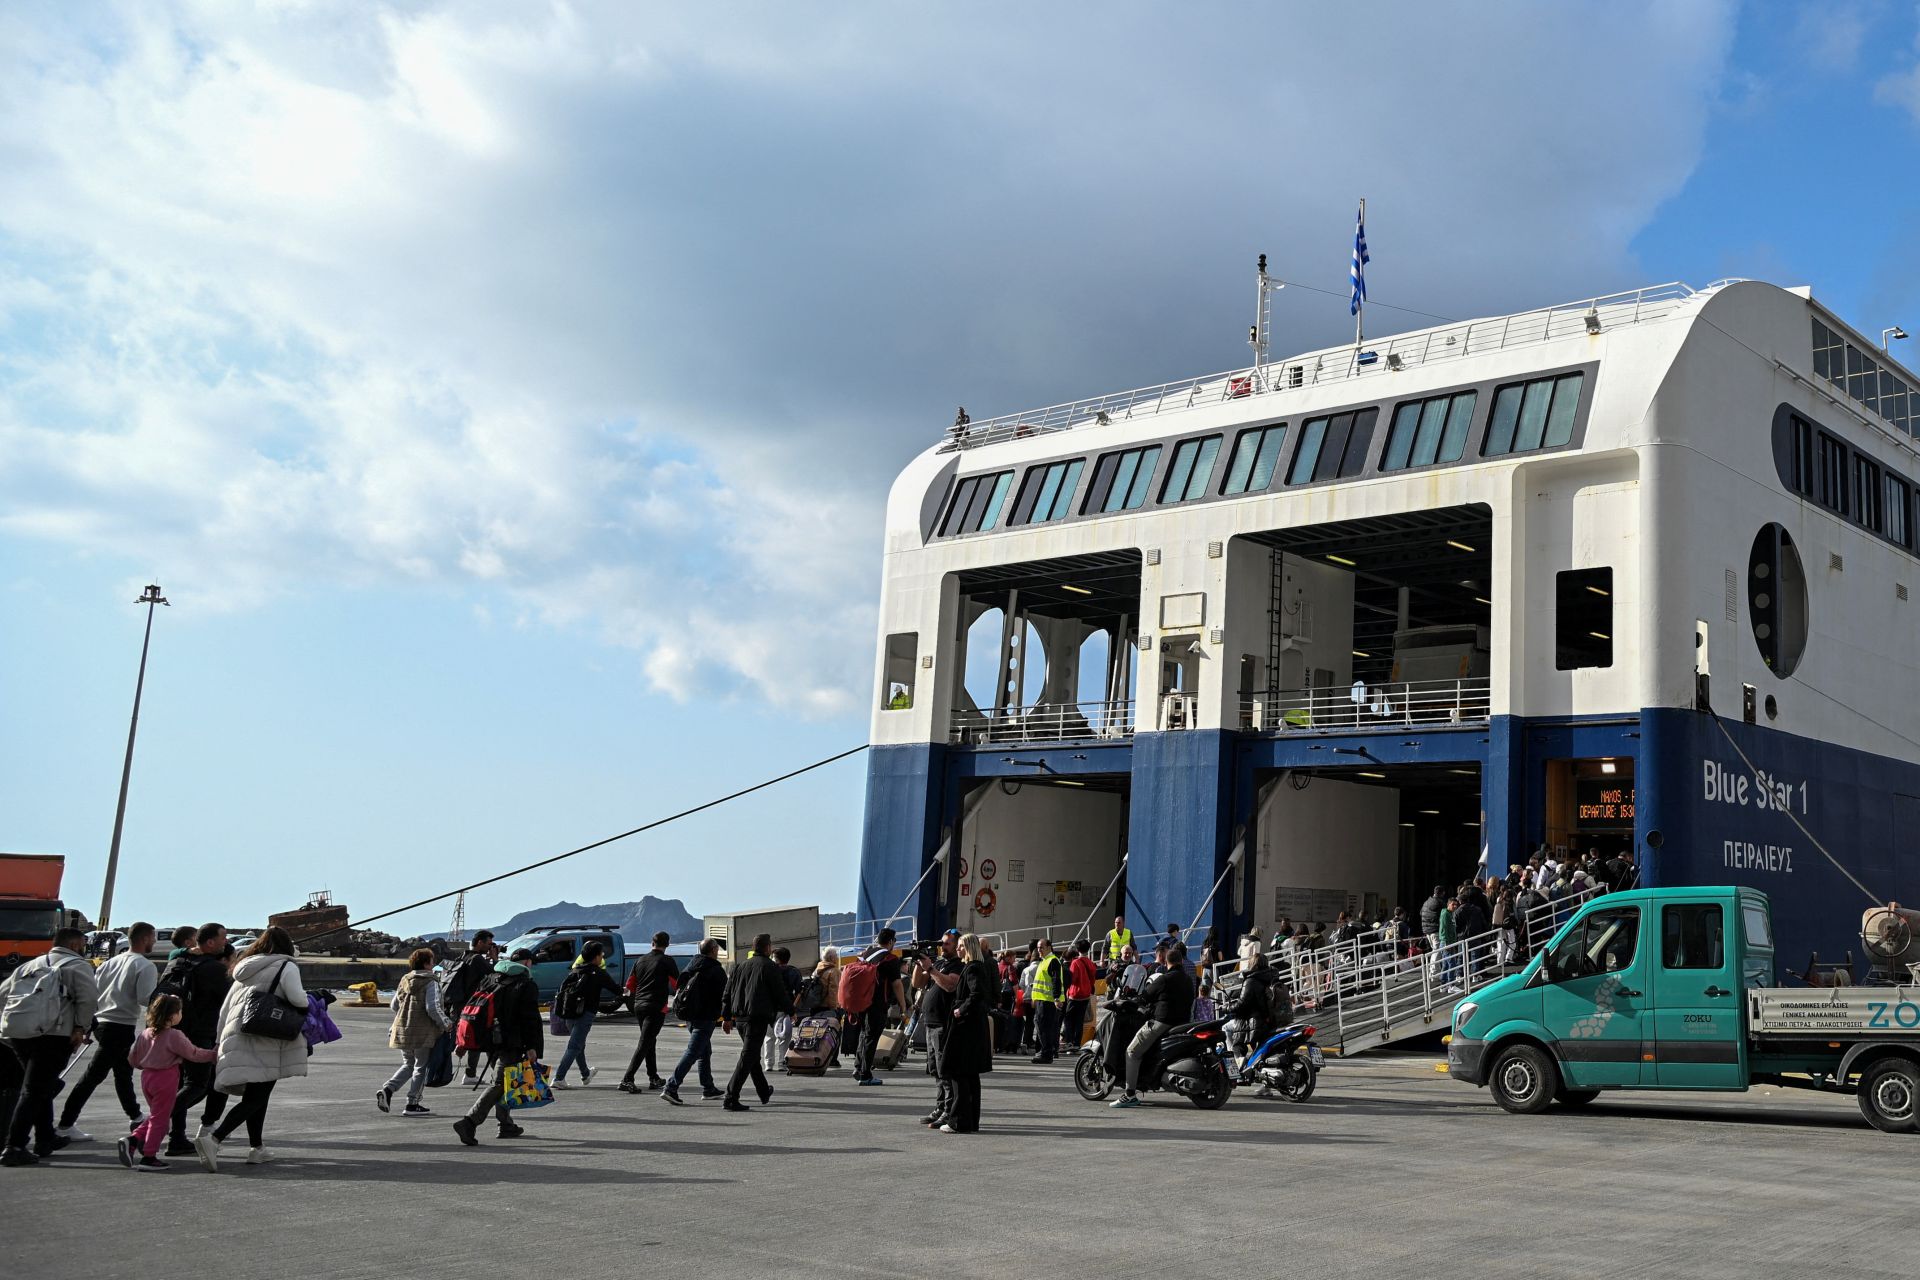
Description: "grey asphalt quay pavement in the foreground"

(0, 1007), (1920, 1280)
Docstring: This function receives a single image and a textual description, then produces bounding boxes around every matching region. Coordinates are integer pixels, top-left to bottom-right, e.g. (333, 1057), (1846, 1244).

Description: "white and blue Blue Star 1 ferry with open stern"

(860, 280), (1920, 967)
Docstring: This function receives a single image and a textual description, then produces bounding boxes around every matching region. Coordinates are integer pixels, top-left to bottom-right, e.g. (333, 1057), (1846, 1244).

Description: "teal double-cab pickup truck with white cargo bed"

(1448, 887), (1920, 1134)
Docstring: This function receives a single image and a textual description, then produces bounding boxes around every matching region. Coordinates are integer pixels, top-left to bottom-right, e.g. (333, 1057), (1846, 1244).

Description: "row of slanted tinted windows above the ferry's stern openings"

(939, 372), (1586, 537)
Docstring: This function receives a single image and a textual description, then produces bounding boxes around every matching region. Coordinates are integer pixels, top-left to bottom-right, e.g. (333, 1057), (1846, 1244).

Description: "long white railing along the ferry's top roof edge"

(943, 280), (1736, 451)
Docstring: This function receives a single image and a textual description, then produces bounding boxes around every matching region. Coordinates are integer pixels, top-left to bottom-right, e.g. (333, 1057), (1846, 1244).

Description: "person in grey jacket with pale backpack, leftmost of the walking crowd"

(0, 929), (100, 1169)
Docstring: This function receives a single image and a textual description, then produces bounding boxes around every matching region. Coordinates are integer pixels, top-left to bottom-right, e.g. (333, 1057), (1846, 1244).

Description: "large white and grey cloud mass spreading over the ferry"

(0, 0), (1730, 712)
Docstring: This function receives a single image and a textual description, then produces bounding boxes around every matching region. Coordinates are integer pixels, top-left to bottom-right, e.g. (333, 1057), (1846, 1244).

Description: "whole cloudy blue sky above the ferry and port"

(0, 0), (1920, 929)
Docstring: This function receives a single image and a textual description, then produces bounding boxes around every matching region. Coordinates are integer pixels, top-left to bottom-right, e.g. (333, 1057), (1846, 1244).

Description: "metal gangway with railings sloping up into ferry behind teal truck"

(1213, 885), (1605, 1057)
